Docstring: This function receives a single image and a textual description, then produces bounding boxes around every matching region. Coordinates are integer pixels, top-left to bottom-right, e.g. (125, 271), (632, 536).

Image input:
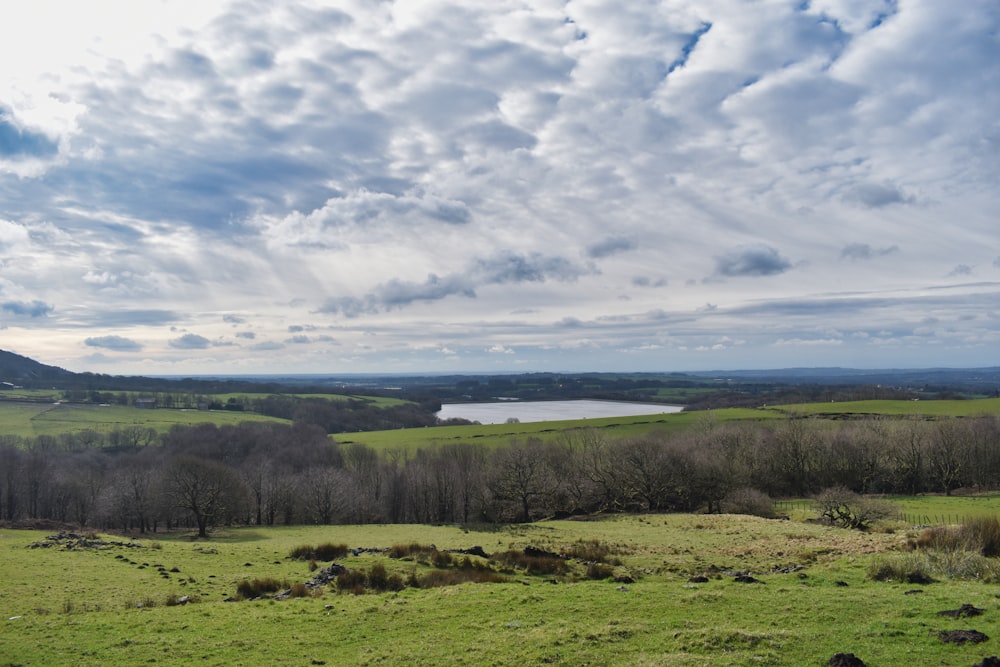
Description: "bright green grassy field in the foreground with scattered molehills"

(0, 515), (1000, 666)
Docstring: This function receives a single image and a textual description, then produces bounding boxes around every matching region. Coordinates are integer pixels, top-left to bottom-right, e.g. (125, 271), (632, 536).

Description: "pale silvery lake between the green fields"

(437, 400), (683, 424)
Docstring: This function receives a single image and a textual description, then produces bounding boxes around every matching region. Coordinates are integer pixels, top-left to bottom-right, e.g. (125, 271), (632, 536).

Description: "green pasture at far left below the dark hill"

(0, 401), (288, 437)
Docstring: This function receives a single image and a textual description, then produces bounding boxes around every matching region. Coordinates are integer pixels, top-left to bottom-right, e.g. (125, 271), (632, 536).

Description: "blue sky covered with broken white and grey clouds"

(0, 0), (1000, 375)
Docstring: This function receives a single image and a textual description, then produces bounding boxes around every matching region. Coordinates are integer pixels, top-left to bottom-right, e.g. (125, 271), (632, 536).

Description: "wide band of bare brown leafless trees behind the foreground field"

(0, 417), (1000, 534)
